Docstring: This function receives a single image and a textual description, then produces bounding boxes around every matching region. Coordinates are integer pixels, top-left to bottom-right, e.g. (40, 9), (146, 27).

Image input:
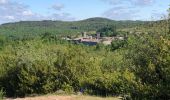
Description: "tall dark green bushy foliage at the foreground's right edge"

(126, 34), (170, 100)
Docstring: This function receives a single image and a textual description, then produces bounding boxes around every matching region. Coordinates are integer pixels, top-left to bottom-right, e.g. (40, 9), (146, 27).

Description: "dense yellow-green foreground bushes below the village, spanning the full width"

(0, 29), (170, 99)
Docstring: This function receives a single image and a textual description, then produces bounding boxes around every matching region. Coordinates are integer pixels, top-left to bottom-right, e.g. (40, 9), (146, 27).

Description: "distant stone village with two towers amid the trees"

(63, 32), (124, 46)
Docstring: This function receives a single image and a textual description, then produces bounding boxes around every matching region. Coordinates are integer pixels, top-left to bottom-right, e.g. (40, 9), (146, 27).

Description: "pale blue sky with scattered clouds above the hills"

(0, 0), (170, 24)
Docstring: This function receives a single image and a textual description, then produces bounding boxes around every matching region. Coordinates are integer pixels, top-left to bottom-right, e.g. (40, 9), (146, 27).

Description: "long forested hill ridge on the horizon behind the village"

(0, 17), (146, 36)
